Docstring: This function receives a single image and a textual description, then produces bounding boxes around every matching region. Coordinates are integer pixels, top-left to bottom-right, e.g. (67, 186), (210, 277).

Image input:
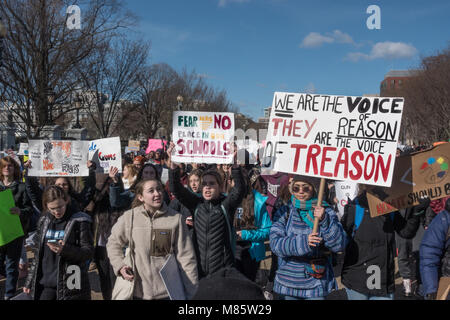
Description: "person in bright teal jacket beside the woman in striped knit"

(232, 169), (272, 281)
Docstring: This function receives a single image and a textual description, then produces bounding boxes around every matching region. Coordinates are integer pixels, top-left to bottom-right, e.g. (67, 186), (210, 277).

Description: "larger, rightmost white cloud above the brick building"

(346, 41), (418, 62)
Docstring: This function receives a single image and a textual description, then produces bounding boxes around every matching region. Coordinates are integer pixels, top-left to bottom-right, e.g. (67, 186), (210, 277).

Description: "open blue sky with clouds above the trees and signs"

(126, 0), (450, 120)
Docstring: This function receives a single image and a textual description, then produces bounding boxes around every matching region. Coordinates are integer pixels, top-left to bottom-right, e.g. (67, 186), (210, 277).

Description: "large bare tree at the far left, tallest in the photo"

(0, 0), (134, 137)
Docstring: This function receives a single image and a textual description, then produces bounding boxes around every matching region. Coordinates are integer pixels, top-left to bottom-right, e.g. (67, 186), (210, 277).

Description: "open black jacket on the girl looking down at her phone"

(25, 206), (94, 300)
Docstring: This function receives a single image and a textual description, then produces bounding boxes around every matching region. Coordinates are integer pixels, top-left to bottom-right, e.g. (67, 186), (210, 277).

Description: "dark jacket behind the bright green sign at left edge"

(0, 181), (33, 236)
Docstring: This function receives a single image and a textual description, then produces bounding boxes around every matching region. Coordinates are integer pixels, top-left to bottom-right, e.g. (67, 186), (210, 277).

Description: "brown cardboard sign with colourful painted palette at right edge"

(367, 143), (450, 217)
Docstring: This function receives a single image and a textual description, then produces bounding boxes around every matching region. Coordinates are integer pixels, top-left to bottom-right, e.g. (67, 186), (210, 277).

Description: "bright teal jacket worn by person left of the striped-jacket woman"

(242, 190), (272, 261)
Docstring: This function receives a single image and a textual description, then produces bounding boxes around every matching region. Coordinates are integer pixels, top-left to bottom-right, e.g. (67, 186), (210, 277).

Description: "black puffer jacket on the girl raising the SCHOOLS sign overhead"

(169, 168), (245, 279)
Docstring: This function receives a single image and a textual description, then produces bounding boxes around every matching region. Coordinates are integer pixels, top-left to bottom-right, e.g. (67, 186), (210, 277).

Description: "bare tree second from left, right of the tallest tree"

(78, 38), (150, 138)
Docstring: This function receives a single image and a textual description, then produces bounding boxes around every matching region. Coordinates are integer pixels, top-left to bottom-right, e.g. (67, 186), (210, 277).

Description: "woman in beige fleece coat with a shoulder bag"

(106, 179), (198, 300)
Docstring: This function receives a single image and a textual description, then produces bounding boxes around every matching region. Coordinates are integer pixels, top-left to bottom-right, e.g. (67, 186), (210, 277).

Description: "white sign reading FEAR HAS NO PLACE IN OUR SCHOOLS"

(172, 111), (234, 164)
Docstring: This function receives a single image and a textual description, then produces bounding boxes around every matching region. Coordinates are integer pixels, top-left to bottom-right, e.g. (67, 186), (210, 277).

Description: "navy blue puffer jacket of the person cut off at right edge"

(420, 199), (450, 300)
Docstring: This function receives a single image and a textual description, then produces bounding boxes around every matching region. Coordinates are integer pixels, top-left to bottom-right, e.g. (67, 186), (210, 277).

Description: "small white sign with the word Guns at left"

(89, 137), (122, 174)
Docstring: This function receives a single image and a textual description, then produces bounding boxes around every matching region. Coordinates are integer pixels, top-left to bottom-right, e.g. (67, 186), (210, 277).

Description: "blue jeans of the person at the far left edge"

(0, 237), (23, 299)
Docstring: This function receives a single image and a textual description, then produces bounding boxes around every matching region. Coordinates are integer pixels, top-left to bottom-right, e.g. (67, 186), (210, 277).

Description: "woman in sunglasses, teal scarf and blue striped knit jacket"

(270, 175), (347, 300)
